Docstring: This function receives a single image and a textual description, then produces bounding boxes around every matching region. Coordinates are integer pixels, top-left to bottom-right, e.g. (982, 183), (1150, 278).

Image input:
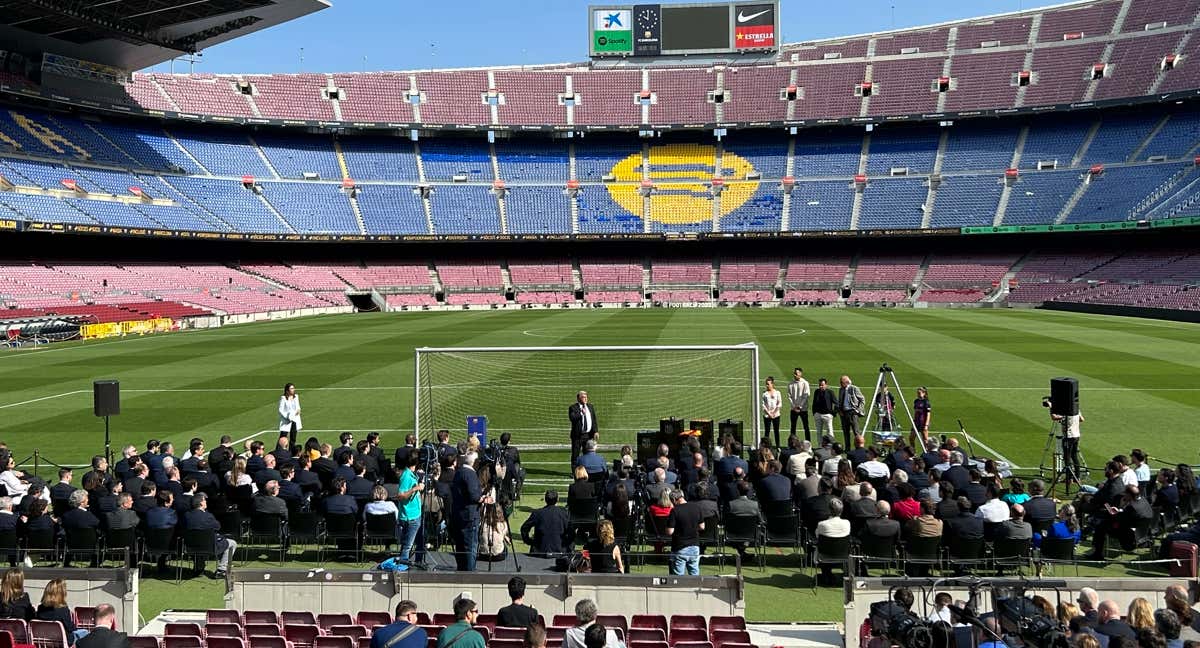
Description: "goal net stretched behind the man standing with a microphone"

(414, 343), (758, 448)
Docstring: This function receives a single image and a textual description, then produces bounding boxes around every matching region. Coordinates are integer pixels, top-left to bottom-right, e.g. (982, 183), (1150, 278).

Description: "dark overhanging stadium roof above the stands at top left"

(0, 0), (330, 70)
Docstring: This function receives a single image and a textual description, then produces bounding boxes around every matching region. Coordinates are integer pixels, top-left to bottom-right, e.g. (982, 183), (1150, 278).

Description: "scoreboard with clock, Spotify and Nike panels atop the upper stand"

(588, 0), (779, 58)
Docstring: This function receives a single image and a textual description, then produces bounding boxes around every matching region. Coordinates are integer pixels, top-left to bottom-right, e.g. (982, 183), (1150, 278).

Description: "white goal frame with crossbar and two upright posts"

(413, 342), (761, 444)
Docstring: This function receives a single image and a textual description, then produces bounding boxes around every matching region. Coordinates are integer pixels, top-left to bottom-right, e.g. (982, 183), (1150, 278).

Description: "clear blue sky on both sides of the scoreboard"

(147, 0), (1054, 73)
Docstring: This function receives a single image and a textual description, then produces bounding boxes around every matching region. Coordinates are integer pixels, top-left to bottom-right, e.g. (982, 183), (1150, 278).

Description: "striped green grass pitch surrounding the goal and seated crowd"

(0, 310), (1200, 620)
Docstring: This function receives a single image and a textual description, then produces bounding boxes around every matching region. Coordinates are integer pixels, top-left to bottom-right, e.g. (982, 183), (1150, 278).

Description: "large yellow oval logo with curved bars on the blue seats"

(608, 144), (758, 224)
